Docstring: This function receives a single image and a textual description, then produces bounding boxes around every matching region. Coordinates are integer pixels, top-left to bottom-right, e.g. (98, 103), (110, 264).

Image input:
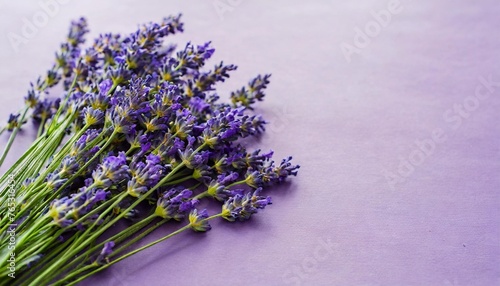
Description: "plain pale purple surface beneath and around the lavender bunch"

(0, 0), (500, 285)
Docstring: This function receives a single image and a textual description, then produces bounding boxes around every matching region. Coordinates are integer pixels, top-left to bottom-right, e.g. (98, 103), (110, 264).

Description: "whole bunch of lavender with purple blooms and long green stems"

(0, 15), (299, 286)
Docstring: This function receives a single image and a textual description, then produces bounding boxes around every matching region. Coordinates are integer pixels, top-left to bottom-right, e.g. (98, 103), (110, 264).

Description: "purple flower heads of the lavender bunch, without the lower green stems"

(0, 15), (299, 282)
